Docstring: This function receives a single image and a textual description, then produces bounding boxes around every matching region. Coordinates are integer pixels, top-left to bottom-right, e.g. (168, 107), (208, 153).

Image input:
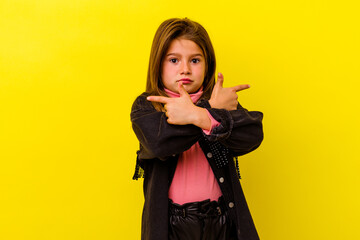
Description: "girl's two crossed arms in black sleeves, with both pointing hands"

(131, 72), (262, 160)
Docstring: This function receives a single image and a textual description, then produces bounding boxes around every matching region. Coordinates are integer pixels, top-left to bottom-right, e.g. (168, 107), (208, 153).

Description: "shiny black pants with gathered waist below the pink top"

(169, 197), (236, 240)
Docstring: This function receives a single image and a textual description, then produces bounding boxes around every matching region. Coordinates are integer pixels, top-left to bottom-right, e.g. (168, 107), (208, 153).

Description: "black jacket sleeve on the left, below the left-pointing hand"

(130, 93), (202, 160)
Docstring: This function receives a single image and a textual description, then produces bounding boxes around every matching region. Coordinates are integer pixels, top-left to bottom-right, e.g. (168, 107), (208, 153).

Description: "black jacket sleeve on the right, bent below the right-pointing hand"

(198, 100), (264, 156)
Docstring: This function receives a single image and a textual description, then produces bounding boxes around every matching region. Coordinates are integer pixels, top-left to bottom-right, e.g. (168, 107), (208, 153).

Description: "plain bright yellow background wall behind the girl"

(0, 0), (360, 240)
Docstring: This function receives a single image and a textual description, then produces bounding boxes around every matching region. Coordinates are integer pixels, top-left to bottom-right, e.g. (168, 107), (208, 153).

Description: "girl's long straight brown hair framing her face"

(146, 18), (216, 111)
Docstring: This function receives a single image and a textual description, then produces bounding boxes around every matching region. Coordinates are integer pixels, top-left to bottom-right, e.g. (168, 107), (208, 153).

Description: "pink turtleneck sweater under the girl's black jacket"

(165, 88), (222, 204)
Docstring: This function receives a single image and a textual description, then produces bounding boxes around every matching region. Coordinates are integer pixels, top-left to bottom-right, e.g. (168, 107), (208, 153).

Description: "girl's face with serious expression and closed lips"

(161, 38), (205, 93)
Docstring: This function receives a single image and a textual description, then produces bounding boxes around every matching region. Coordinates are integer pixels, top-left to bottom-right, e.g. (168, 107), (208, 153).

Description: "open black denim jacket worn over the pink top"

(131, 93), (263, 240)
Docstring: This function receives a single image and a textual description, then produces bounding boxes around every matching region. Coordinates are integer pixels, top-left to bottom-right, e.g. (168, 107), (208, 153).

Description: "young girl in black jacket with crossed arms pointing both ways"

(131, 18), (263, 240)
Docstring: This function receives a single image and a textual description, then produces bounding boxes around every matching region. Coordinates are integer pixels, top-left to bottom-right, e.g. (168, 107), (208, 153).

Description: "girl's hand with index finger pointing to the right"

(209, 73), (250, 111)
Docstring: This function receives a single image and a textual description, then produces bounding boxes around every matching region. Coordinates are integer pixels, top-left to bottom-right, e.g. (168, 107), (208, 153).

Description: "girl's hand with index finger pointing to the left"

(147, 82), (211, 130)
